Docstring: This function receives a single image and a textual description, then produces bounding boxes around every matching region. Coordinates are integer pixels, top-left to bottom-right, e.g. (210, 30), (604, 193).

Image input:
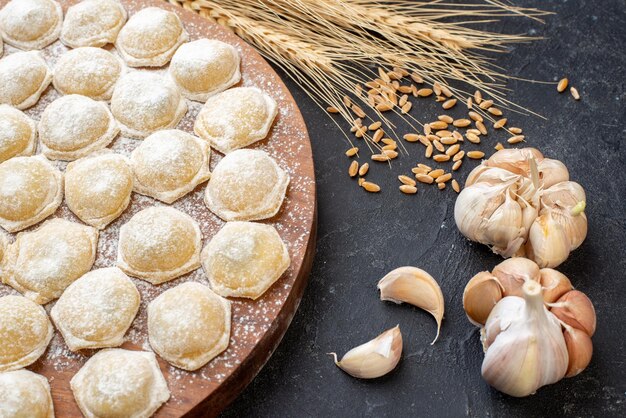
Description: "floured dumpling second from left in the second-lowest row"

(50, 267), (140, 351)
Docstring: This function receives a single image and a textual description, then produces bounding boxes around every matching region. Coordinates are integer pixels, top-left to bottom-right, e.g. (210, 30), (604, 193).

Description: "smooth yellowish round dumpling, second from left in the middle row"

(65, 150), (133, 229)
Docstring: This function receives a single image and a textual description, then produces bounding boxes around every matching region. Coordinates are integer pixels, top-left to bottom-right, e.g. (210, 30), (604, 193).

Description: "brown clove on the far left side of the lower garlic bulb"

(463, 271), (502, 326)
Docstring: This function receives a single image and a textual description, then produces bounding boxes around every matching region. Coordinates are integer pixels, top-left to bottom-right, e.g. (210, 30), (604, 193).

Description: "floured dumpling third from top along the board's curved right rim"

(193, 87), (277, 154)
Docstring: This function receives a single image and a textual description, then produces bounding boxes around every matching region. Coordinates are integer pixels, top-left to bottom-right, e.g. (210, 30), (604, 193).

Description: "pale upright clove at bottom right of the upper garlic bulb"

(526, 210), (571, 268)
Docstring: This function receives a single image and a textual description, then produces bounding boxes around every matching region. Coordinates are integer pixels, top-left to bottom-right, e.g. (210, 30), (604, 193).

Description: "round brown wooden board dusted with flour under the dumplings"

(0, 0), (316, 417)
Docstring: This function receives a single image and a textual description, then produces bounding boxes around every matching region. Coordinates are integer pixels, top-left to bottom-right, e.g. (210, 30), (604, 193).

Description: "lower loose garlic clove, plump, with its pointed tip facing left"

(329, 325), (402, 379)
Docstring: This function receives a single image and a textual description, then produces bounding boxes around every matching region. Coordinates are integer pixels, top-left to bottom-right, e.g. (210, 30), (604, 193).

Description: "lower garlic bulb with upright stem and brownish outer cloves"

(463, 257), (596, 396)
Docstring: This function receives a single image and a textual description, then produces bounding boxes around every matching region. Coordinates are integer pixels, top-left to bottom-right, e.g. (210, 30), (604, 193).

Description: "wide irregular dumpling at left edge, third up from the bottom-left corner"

(2, 218), (98, 305)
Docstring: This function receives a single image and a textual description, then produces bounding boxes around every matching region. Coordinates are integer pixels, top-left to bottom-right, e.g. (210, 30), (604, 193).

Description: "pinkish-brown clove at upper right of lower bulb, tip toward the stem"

(548, 290), (596, 337)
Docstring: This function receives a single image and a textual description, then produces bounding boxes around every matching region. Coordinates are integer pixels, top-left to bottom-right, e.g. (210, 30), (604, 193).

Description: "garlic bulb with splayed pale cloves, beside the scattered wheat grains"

(454, 148), (587, 267)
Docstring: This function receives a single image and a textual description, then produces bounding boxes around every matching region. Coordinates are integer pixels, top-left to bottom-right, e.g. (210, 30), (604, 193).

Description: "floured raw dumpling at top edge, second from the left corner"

(61, 0), (128, 48)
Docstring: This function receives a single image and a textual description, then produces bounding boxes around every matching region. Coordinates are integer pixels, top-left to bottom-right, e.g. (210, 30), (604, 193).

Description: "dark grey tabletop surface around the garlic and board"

(224, 0), (626, 417)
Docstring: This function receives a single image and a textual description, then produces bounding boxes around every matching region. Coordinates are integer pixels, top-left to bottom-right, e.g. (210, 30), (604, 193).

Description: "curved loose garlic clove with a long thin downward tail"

(378, 266), (444, 345)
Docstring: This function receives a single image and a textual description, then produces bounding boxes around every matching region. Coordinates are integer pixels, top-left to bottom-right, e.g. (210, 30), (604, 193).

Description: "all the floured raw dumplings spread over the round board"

(0, 0), (290, 418)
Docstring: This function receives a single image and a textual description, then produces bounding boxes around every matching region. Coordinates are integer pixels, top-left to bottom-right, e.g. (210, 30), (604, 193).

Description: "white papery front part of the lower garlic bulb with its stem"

(481, 281), (569, 397)
